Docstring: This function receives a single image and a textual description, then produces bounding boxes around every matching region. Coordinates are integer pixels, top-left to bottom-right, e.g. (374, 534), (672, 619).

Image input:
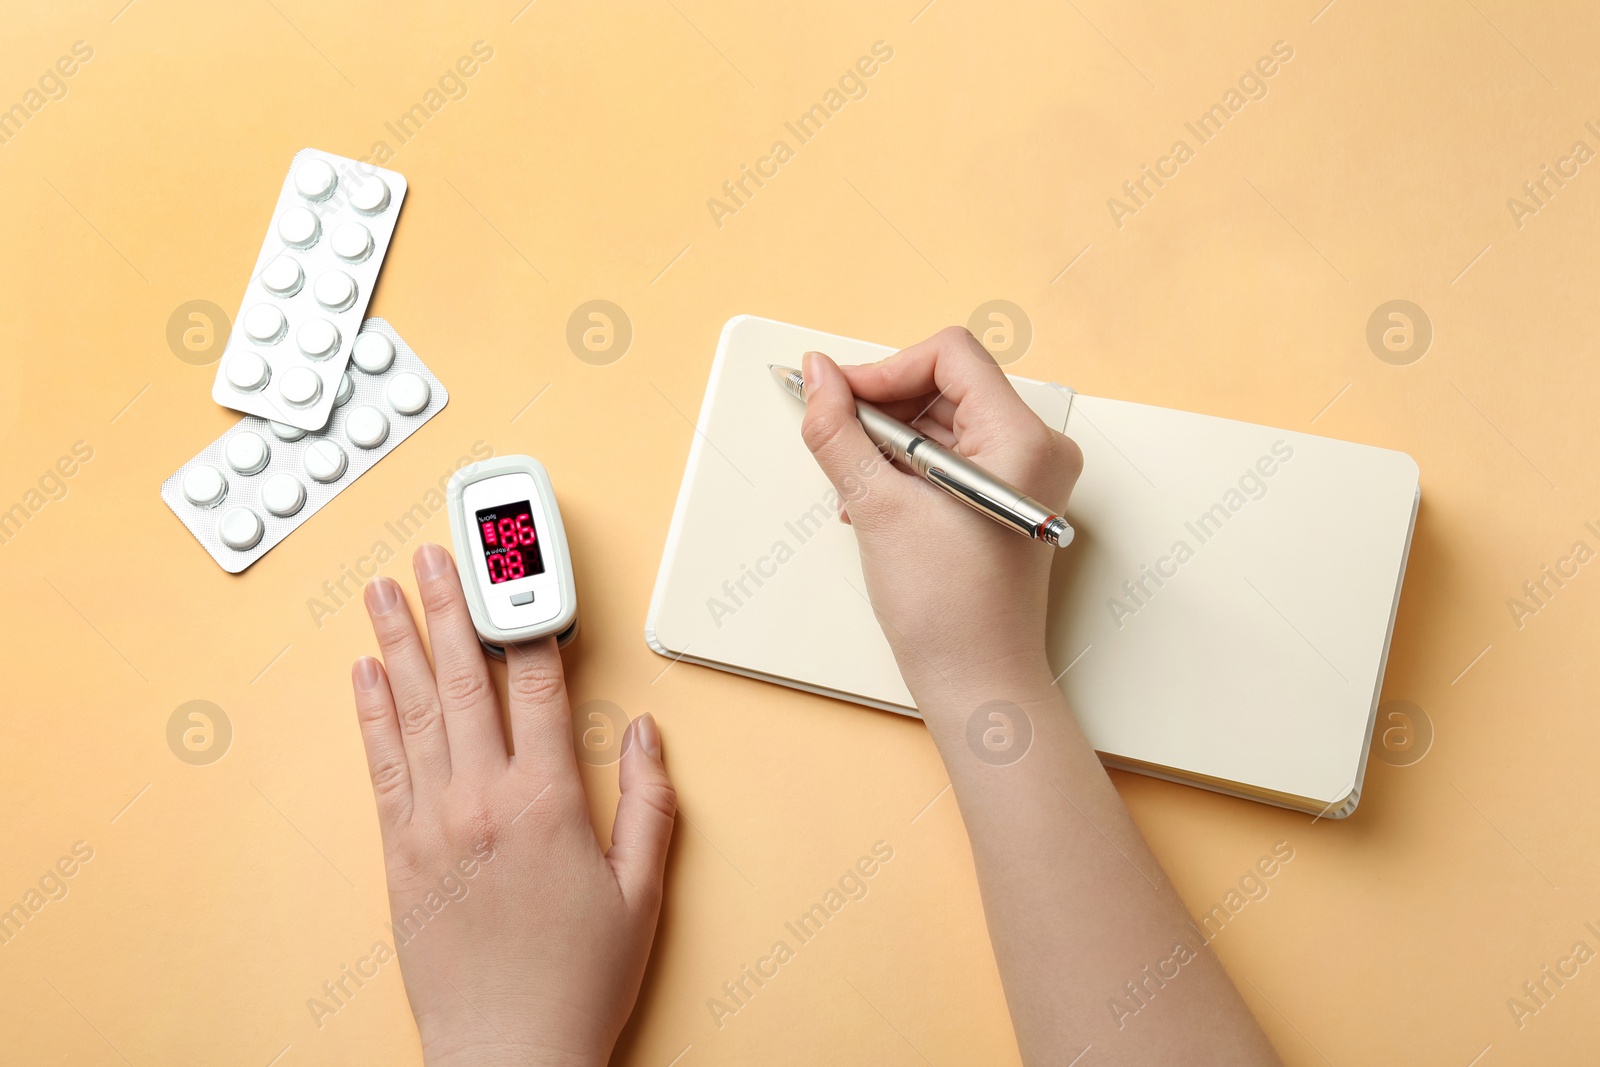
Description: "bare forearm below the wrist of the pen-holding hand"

(918, 664), (1277, 1064)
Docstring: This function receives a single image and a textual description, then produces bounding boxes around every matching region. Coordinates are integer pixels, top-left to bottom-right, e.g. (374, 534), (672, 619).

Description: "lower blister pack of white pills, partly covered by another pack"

(162, 318), (450, 574)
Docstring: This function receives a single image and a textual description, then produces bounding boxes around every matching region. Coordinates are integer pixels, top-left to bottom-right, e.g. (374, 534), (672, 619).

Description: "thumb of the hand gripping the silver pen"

(800, 352), (904, 526)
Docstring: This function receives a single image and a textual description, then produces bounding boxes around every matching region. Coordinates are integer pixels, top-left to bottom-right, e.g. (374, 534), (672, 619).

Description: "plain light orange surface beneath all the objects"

(0, 0), (1600, 1067)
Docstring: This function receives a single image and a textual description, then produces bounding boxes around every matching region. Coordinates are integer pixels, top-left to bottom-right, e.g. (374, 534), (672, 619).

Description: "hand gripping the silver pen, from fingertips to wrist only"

(802, 326), (1083, 713)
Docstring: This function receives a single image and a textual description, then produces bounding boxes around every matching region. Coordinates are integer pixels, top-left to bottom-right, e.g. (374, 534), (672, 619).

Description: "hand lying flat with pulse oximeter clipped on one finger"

(352, 544), (677, 1067)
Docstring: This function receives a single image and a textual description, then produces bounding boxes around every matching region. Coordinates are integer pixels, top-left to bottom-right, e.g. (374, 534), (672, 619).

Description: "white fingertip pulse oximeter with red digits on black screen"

(446, 456), (578, 657)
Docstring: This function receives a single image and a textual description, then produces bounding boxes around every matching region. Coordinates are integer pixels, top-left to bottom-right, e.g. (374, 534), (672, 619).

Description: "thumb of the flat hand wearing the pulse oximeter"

(606, 712), (678, 913)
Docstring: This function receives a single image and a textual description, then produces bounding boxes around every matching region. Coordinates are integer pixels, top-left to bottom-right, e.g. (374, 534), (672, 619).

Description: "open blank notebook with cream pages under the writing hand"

(645, 315), (1421, 817)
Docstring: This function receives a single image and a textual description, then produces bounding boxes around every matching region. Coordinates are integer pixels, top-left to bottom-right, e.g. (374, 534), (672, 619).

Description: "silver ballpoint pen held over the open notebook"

(766, 363), (1072, 549)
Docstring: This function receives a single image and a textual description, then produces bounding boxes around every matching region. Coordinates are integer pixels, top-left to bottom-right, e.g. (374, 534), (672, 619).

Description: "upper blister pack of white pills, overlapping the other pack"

(211, 149), (406, 430)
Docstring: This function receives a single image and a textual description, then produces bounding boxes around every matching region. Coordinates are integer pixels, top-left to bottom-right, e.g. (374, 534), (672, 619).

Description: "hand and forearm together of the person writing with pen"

(805, 328), (1277, 1065)
